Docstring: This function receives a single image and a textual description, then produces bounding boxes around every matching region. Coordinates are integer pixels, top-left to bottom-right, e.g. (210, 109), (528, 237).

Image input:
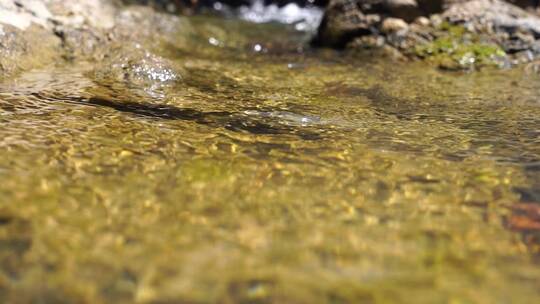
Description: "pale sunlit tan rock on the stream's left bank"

(0, 0), (190, 77)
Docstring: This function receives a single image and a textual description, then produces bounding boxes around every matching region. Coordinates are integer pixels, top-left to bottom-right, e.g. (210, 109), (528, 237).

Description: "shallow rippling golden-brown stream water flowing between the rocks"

(0, 18), (540, 303)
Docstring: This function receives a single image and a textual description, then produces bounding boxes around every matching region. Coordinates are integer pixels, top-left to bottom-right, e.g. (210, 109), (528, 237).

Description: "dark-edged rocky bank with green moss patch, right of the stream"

(314, 0), (540, 69)
